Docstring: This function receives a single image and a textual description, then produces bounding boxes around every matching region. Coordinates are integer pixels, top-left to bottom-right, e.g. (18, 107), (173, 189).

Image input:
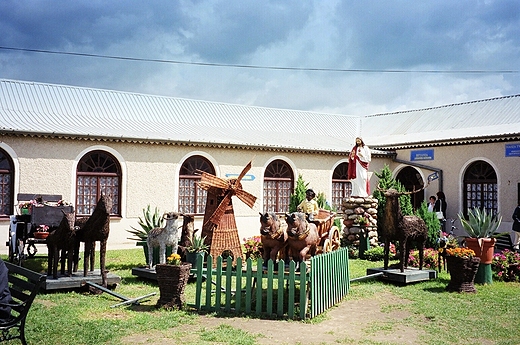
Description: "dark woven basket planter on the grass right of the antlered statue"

(446, 256), (480, 292)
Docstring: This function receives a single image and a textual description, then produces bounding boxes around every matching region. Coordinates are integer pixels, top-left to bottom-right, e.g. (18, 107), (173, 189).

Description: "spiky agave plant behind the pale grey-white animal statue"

(126, 205), (172, 265)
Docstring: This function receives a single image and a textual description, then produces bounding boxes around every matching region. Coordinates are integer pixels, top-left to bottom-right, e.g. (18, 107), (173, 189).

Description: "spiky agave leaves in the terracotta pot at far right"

(458, 207), (502, 238)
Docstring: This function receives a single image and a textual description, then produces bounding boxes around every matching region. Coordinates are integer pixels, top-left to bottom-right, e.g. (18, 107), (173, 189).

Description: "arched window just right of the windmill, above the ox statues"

(264, 159), (294, 213)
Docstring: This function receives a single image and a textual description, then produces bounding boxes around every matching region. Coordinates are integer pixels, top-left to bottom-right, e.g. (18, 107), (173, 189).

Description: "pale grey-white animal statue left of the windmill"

(146, 212), (180, 269)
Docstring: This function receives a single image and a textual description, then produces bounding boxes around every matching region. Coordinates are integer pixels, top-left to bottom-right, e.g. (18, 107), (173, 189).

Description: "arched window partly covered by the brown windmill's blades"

(179, 156), (215, 214)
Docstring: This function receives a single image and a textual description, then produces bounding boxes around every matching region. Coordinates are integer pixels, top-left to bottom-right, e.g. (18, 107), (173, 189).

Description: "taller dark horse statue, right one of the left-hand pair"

(74, 194), (112, 287)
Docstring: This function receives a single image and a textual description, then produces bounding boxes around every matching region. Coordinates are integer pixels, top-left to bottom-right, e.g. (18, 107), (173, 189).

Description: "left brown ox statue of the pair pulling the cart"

(259, 212), (289, 266)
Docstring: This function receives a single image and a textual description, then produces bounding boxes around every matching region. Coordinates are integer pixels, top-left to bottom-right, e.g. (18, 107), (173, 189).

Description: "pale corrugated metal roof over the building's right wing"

(363, 95), (520, 148)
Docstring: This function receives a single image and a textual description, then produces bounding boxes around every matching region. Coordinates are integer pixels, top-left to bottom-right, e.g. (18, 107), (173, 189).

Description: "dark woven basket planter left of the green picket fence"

(155, 262), (191, 309)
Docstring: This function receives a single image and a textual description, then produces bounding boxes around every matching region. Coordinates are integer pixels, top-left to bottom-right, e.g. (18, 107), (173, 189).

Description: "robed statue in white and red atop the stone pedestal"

(347, 137), (372, 197)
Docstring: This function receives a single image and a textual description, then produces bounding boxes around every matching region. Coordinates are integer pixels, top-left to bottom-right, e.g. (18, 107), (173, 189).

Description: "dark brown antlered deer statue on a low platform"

(378, 186), (428, 272)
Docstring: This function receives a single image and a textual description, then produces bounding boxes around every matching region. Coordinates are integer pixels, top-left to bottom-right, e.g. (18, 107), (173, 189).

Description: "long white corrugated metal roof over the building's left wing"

(0, 80), (360, 152)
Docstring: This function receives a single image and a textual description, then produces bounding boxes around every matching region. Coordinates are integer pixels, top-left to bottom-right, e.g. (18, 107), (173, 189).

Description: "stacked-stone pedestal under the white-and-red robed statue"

(342, 196), (379, 248)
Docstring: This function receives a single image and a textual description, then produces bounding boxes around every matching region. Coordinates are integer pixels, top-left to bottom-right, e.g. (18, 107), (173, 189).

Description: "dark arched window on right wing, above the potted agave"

(464, 161), (498, 215)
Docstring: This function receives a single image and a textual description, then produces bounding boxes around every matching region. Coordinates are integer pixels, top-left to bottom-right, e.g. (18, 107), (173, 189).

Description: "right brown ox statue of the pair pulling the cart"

(285, 212), (320, 267)
